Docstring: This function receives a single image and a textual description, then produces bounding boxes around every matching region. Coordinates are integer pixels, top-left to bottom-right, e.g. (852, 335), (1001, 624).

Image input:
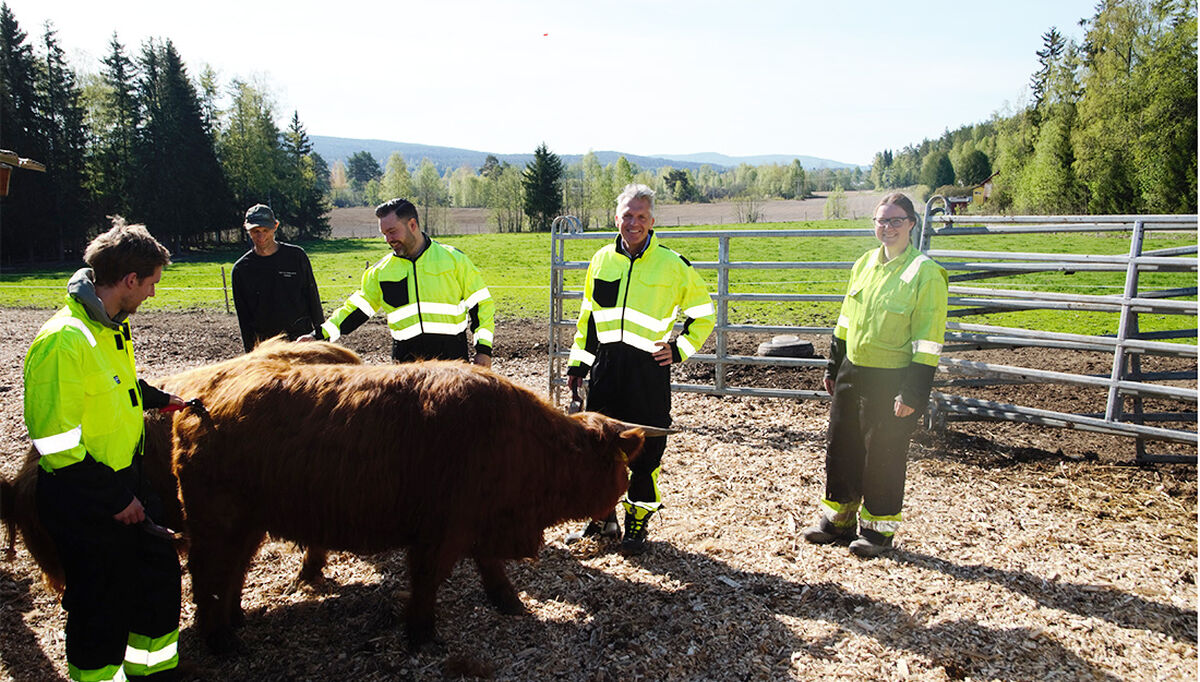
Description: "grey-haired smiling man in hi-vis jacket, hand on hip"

(568, 185), (715, 555)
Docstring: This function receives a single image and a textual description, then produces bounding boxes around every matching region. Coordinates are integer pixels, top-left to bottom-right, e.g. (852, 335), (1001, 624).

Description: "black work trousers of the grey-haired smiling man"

(587, 343), (671, 502)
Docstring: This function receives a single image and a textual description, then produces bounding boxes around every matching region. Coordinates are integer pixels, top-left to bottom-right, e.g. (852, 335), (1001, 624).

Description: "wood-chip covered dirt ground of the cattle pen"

(0, 310), (1198, 681)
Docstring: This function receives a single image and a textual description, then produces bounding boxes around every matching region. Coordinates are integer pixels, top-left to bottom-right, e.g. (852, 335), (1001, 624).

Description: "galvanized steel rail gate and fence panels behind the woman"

(548, 206), (1196, 461)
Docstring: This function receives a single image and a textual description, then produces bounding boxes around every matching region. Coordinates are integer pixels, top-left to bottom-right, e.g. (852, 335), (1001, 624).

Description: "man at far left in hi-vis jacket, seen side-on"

(24, 221), (184, 681)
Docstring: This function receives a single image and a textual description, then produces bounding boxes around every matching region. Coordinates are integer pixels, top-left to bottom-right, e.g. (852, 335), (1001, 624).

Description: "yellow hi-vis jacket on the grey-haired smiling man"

(568, 232), (716, 376)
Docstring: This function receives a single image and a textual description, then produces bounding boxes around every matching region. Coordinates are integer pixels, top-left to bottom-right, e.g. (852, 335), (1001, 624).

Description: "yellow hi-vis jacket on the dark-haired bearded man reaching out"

(320, 235), (496, 355)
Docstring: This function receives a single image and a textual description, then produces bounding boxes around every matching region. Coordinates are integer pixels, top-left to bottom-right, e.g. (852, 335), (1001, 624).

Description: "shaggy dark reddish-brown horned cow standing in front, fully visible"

(175, 361), (643, 651)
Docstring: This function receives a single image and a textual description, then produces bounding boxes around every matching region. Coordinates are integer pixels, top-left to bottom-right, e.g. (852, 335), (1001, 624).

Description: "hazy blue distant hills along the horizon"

(308, 134), (853, 172)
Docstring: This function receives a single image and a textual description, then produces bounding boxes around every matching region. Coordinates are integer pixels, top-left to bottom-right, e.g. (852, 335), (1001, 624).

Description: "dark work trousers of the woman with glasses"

(826, 360), (923, 528)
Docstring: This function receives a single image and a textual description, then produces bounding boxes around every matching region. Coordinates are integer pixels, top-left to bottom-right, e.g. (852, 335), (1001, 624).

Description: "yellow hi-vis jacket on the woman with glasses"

(829, 244), (949, 407)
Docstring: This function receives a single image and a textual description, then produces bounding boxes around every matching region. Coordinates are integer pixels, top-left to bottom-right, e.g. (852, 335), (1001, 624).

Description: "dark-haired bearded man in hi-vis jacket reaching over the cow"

(309, 199), (496, 367)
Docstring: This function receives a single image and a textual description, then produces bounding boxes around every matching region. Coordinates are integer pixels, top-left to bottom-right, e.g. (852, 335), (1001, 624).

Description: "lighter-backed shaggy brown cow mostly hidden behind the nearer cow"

(0, 336), (362, 593)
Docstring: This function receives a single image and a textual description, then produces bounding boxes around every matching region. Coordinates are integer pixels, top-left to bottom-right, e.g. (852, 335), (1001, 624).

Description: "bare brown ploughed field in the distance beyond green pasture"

(329, 191), (883, 238)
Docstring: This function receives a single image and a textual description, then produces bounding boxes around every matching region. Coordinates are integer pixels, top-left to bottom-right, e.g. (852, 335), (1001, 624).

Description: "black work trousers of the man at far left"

(37, 469), (180, 670)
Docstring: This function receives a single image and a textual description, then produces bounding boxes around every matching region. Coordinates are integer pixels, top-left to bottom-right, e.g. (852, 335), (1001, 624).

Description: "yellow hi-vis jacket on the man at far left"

(25, 298), (143, 471)
